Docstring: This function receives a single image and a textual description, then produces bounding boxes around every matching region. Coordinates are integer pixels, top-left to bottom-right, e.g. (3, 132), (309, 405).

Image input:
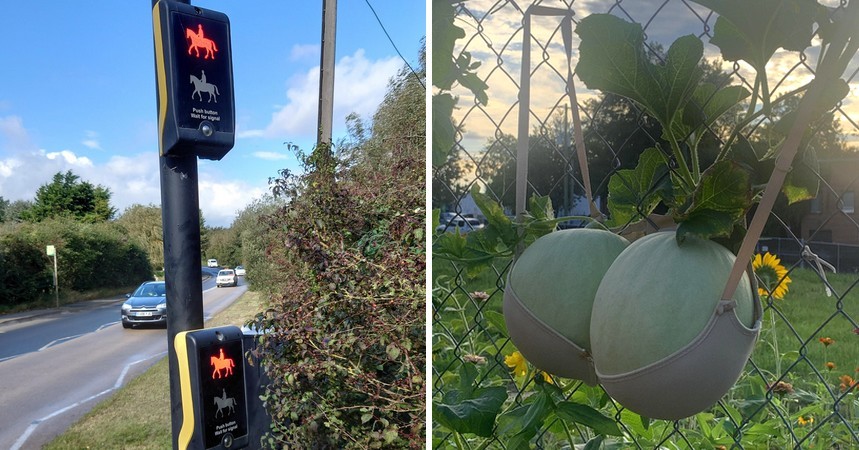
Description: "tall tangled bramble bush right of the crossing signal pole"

(254, 46), (426, 449)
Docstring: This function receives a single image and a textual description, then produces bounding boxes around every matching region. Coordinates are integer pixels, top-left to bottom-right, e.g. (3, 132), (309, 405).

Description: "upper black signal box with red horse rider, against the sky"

(152, 0), (236, 160)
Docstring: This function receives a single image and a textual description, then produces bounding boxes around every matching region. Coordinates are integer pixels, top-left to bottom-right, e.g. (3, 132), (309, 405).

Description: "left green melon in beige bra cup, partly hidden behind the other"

(504, 229), (629, 384)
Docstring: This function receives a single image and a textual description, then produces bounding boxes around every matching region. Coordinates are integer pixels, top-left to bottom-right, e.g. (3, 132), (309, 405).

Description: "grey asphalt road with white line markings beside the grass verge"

(0, 270), (247, 450)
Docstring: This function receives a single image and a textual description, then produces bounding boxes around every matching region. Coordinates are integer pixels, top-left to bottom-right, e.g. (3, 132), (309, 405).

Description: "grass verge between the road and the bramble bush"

(44, 291), (264, 450)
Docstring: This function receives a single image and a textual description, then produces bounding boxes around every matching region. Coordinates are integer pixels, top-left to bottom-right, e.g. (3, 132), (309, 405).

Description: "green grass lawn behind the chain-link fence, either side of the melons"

(432, 258), (859, 385)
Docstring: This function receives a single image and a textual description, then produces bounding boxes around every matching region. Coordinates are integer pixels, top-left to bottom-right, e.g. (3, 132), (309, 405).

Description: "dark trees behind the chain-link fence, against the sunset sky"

(480, 51), (730, 216)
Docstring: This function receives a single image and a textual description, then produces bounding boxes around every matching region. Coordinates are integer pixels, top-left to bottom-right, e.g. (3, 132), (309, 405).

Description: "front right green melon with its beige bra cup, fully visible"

(590, 232), (761, 420)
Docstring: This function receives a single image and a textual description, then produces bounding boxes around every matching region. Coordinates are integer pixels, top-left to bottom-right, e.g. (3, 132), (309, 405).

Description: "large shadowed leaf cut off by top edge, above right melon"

(692, 0), (821, 72)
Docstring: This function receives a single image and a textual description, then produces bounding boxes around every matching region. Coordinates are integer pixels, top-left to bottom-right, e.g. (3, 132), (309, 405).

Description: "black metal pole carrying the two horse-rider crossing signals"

(152, 0), (203, 449)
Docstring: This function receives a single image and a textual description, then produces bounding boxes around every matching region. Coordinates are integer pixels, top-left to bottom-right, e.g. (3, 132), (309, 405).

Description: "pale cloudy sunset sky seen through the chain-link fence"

(453, 0), (859, 161)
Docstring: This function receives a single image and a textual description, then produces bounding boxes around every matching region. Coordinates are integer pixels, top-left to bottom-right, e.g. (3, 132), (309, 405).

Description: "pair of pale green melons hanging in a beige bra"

(504, 229), (756, 419)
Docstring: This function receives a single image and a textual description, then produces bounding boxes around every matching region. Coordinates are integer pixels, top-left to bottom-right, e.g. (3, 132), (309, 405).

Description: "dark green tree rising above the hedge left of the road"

(21, 170), (116, 223)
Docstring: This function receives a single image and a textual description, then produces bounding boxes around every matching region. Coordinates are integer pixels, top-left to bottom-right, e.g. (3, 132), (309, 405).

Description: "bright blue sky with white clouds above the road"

(0, 0), (427, 227)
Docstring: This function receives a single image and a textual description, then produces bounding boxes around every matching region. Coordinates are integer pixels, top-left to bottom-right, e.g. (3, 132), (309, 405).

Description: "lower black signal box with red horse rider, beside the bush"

(173, 326), (248, 450)
